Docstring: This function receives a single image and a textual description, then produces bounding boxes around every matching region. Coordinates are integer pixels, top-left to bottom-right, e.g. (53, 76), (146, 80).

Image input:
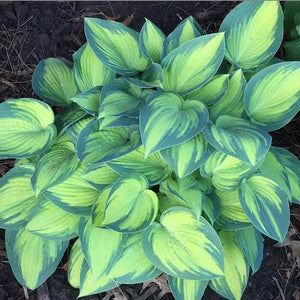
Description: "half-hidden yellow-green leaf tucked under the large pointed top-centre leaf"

(185, 74), (229, 106)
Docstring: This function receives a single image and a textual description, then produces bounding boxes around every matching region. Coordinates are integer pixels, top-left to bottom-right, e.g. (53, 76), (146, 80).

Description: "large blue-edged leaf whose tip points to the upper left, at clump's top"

(84, 18), (148, 76)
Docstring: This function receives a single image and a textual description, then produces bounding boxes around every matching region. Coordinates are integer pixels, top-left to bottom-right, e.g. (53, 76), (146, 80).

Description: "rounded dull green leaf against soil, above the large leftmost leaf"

(31, 58), (77, 106)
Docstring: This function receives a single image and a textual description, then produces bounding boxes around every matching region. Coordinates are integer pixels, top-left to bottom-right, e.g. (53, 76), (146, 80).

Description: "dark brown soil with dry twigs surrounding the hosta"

(0, 1), (300, 300)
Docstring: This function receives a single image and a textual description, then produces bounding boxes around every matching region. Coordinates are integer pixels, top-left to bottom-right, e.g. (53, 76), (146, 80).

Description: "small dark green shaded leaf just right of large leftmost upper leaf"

(55, 103), (88, 136)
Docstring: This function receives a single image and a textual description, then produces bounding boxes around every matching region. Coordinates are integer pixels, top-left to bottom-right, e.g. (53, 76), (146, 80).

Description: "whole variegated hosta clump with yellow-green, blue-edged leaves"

(0, 1), (300, 300)
